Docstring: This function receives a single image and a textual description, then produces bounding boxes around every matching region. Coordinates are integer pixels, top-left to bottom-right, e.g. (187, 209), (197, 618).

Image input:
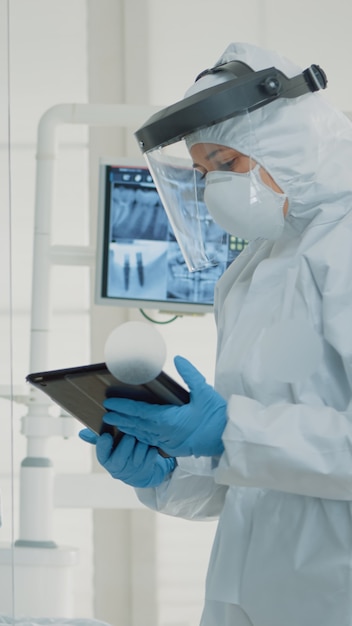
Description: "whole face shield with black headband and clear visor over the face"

(135, 61), (327, 271)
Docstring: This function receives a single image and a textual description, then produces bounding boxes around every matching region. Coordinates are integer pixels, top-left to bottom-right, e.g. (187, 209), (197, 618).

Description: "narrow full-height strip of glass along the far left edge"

(0, 2), (16, 617)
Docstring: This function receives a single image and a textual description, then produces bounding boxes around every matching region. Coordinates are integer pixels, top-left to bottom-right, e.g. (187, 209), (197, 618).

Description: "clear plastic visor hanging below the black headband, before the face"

(145, 114), (255, 273)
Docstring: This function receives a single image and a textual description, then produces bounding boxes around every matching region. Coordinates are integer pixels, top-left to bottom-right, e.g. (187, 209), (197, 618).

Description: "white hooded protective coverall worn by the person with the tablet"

(137, 44), (352, 626)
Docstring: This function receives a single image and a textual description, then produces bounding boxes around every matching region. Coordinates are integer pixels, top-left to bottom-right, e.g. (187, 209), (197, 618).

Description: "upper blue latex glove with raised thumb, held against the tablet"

(103, 356), (226, 456)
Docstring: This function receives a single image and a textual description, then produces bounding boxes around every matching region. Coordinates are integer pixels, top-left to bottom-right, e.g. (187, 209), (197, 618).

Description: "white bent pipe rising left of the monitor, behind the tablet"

(19, 104), (157, 545)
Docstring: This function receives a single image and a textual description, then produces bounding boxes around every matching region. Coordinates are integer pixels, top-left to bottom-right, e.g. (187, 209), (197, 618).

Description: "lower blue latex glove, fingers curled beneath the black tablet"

(79, 428), (176, 487)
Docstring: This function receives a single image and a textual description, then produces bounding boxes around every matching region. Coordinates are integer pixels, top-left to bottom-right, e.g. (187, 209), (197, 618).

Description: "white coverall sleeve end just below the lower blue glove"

(136, 457), (227, 520)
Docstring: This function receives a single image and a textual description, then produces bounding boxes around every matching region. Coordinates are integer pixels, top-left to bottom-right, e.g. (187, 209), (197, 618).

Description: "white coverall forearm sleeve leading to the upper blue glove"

(216, 396), (352, 500)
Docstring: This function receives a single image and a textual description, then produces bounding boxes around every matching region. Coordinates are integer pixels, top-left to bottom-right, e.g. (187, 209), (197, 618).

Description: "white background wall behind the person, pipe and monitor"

(0, 0), (352, 626)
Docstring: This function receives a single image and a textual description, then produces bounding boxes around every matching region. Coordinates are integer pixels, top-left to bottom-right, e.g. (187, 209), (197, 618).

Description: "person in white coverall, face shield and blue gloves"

(81, 44), (352, 626)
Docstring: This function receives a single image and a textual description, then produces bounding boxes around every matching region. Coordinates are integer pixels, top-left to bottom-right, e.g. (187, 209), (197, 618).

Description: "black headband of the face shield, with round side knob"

(135, 61), (327, 152)
